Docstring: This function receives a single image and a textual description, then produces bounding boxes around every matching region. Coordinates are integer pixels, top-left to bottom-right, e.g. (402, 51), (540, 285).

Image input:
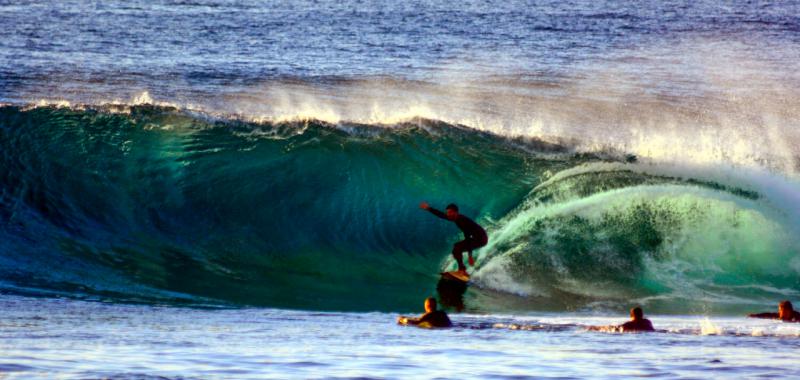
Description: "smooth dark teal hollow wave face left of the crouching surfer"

(0, 106), (544, 309)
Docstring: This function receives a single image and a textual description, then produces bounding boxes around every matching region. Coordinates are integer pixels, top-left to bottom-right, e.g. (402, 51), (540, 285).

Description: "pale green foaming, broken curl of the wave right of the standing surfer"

(474, 164), (800, 312)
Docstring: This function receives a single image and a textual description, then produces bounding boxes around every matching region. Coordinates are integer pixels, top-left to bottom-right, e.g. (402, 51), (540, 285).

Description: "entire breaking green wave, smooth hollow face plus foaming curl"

(0, 106), (800, 310)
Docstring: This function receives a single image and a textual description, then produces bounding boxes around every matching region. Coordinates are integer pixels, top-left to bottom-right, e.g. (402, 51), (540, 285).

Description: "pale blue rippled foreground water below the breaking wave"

(0, 296), (800, 378)
